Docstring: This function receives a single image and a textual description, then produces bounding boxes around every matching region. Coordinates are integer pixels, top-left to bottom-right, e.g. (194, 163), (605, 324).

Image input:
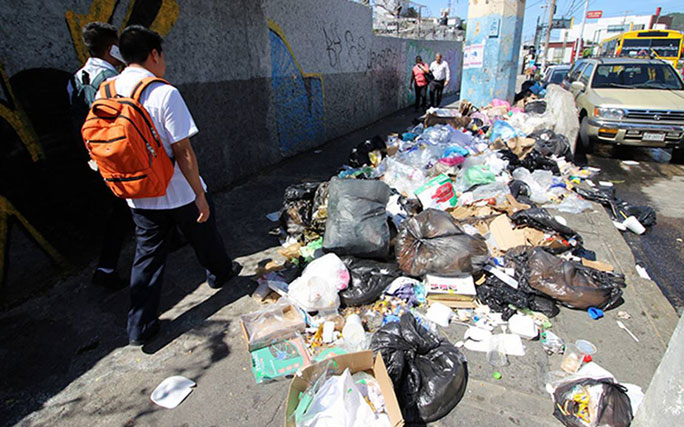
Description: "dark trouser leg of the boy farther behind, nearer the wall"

(97, 195), (133, 273)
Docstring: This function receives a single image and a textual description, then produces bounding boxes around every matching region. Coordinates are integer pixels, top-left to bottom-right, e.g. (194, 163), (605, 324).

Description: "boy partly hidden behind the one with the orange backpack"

(67, 22), (132, 290)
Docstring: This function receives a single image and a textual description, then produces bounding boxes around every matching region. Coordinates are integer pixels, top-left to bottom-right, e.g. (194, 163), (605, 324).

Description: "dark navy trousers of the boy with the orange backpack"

(128, 196), (232, 340)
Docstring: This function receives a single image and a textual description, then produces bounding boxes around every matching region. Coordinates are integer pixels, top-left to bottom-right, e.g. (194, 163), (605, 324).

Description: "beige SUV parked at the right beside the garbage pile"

(562, 58), (684, 163)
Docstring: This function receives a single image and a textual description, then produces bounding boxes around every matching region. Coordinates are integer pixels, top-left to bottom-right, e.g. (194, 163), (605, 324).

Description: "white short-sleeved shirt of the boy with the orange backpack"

(106, 67), (207, 209)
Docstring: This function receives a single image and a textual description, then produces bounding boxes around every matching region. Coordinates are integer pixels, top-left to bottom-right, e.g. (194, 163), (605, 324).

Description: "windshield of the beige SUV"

(591, 64), (684, 90)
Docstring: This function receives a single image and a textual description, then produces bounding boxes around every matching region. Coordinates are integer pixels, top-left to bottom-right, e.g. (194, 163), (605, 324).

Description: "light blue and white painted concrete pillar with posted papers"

(461, 0), (525, 107)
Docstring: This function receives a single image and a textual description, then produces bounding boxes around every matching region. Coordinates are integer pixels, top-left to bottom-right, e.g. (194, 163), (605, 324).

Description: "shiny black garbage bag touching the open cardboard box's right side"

(371, 313), (468, 423)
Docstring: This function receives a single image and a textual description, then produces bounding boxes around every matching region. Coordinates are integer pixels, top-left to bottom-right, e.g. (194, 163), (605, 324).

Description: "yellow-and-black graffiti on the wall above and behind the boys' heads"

(65, 0), (179, 62)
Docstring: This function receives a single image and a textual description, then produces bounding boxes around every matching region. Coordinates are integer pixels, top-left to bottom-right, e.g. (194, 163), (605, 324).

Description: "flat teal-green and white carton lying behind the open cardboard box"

(250, 337), (311, 384)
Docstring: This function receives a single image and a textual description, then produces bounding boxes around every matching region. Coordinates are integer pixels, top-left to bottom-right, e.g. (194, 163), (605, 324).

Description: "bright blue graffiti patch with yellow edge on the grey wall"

(268, 20), (325, 155)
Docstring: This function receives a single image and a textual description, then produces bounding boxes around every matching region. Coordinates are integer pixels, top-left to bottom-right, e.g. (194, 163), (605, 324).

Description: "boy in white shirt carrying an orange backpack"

(82, 25), (241, 345)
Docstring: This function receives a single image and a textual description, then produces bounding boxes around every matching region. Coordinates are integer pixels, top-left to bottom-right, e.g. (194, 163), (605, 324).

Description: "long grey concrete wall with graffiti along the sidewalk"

(0, 0), (461, 301)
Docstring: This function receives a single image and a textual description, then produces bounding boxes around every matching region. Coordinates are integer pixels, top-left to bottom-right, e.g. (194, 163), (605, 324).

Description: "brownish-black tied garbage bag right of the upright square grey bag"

(395, 209), (489, 277)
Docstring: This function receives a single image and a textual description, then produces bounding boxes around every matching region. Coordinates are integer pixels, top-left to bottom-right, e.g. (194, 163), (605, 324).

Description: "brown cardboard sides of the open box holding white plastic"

(285, 351), (404, 427)
